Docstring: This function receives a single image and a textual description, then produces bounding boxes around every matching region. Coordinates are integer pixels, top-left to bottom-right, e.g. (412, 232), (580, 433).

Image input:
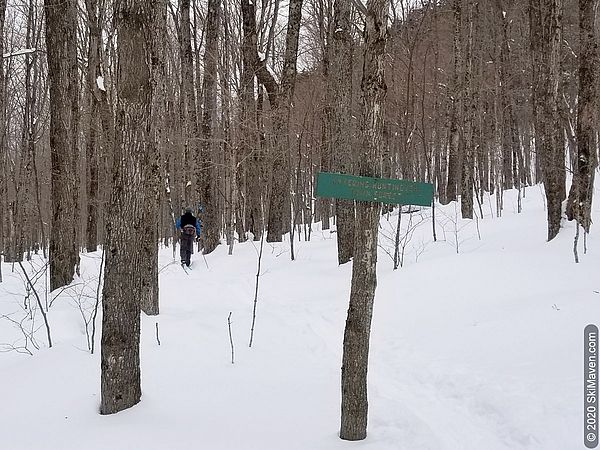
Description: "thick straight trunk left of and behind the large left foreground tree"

(44, 0), (79, 290)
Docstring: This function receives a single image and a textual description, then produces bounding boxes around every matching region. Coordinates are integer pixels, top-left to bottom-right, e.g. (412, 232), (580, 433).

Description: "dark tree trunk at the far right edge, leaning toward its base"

(567, 0), (600, 233)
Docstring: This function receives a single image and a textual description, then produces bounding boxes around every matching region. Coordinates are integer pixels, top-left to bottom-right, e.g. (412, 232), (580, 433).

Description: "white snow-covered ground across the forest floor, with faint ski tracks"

(0, 186), (600, 450)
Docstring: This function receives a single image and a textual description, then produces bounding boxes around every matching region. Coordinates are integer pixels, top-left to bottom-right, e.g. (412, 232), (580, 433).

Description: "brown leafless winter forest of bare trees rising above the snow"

(0, 0), (600, 440)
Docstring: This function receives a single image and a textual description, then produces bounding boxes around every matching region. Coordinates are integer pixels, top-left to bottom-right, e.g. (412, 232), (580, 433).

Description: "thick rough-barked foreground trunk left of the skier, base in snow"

(100, 0), (159, 414)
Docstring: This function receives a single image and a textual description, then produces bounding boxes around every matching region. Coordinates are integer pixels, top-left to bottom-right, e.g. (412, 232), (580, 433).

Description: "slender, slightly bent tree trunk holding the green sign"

(340, 0), (389, 441)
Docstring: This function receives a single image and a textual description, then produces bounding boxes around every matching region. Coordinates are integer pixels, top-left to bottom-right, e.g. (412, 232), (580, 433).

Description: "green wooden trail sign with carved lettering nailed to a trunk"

(315, 172), (433, 206)
